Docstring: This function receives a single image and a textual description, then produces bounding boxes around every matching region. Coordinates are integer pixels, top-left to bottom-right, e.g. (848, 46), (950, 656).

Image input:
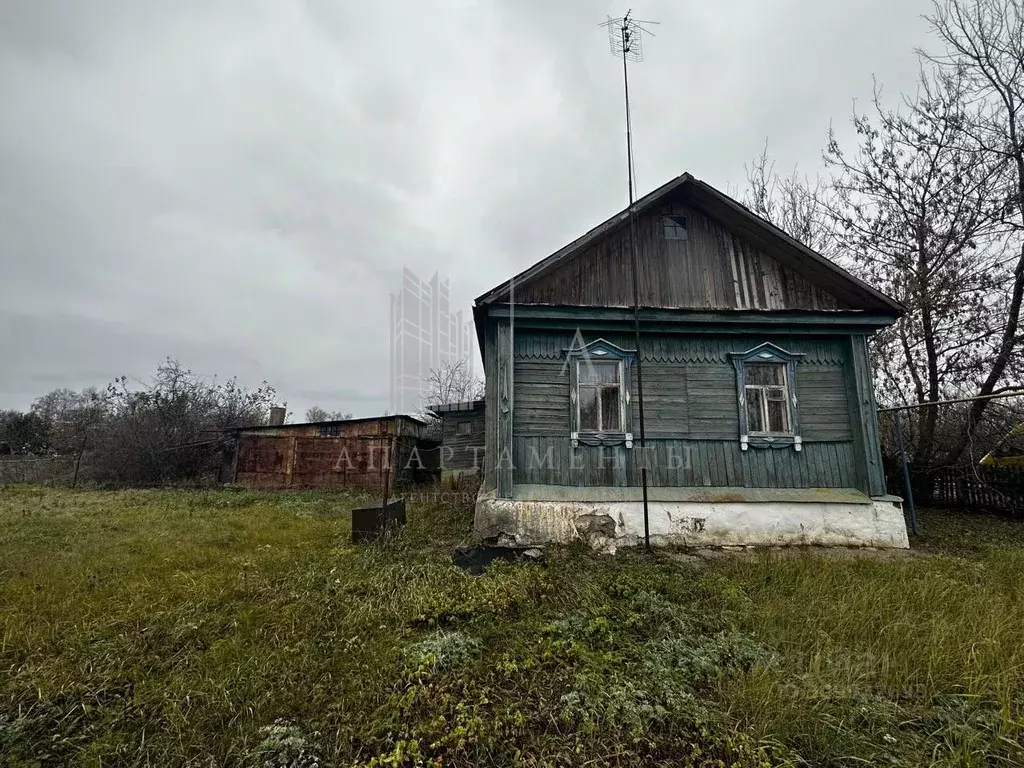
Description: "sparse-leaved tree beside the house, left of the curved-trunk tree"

(824, 73), (1012, 465)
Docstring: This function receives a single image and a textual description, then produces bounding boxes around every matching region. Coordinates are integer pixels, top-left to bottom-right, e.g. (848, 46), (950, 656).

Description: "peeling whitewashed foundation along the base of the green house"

(475, 488), (910, 552)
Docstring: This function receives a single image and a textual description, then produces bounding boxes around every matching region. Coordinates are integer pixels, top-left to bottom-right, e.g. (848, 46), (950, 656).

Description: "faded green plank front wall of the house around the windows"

(512, 331), (866, 489)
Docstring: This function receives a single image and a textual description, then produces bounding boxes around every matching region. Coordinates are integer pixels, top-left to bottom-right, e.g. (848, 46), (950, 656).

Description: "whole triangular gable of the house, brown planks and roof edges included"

(477, 174), (902, 316)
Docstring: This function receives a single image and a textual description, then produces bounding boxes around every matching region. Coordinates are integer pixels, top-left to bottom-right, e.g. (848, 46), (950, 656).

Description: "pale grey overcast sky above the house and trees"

(0, 0), (930, 420)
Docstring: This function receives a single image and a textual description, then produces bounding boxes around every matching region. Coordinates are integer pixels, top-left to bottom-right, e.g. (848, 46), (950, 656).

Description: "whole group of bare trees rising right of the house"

(744, 0), (1024, 468)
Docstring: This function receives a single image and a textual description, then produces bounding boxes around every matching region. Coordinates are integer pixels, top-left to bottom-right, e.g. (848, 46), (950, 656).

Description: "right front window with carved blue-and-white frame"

(730, 342), (804, 451)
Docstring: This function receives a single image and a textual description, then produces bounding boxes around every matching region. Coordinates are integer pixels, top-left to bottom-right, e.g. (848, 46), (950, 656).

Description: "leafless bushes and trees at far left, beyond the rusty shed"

(0, 358), (278, 485)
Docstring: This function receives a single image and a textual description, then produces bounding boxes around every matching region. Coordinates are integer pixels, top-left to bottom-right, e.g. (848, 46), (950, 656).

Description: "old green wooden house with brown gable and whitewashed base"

(474, 174), (907, 549)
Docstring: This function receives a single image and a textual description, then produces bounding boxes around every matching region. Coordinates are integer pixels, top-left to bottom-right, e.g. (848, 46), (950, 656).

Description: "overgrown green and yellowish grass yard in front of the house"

(0, 487), (1024, 768)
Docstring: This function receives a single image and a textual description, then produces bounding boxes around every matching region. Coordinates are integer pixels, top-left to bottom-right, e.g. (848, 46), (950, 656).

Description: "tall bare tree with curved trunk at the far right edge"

(921, 0), (1024, 460)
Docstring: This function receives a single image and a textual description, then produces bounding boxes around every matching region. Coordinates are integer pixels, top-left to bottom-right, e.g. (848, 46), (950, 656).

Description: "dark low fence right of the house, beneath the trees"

(913, 466), (1024, 517)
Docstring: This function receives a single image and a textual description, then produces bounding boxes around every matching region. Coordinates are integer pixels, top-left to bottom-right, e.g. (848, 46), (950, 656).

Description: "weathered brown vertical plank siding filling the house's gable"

(515, 203), (856, 310)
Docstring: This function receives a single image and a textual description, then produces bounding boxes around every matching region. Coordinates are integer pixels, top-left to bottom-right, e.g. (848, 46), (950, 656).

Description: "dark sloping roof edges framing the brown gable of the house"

(475, 173), (903, 316)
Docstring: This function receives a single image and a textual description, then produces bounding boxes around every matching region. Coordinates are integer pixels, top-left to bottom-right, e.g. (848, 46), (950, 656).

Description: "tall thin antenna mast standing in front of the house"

(601, 9), (657, 550)
